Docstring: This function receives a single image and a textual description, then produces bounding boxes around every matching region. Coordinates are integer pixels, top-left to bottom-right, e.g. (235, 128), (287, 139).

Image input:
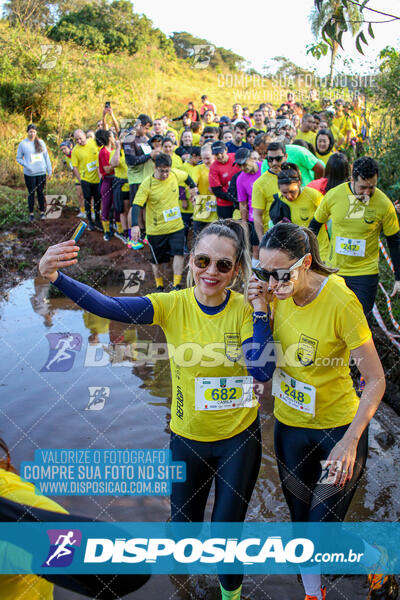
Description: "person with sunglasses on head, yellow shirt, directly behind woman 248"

(269, 162), (329, 260)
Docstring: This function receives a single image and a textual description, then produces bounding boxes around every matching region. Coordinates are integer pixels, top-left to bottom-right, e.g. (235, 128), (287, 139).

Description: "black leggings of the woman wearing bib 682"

(170, 417), (261, 590)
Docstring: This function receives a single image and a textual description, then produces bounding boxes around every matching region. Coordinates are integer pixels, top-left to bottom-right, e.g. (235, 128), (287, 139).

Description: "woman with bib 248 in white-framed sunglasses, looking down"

(248, 223), (395, 600)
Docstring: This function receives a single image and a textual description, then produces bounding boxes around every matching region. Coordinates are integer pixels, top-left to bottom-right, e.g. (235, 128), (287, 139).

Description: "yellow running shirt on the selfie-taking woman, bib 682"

(147, 287), (258, 442)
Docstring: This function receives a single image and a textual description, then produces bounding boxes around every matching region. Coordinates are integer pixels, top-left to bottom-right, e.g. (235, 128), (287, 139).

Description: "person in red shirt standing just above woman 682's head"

(208, 142), (240, 219)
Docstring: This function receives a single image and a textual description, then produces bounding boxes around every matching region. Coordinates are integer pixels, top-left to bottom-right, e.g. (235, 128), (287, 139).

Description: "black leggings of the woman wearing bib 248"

(275, 421), (368, 522)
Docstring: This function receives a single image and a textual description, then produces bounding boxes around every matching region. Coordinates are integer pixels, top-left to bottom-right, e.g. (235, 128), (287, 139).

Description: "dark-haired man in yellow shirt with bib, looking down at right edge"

(310, 156), (400, 317)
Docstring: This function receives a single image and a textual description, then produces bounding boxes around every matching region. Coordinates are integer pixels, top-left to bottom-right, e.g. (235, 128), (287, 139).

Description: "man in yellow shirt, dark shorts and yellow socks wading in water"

(131, 153), (197, 292)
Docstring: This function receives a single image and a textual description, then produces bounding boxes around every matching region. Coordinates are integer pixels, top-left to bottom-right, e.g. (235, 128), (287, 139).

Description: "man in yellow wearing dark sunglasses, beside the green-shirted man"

(251, 142), (287, 242)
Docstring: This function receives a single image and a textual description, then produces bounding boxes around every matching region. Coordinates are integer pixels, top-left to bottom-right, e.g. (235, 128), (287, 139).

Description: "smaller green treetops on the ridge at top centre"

(171, 31), (244, 71)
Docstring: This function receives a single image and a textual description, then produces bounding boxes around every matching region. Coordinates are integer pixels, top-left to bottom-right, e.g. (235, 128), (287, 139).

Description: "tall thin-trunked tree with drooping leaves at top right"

(309, 0), (361, 87)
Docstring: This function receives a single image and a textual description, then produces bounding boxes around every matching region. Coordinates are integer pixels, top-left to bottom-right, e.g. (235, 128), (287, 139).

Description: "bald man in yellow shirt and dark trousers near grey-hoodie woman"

(71, 129), (103, 231)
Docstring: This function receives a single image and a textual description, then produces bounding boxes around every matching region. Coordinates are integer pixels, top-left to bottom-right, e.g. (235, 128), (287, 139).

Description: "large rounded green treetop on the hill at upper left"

(48, 0), (173, 54)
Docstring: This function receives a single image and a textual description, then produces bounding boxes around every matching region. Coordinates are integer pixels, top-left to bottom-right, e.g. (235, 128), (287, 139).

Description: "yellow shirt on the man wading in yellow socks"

(134, 169), (187, 235)
